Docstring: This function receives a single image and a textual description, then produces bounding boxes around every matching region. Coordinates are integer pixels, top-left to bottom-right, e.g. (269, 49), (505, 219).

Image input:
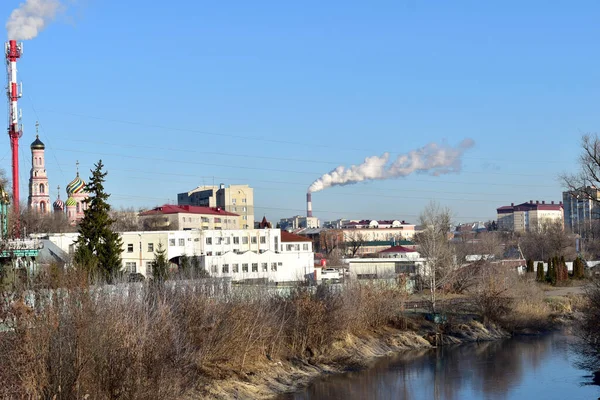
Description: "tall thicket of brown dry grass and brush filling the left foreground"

(0, 279), (406, 400)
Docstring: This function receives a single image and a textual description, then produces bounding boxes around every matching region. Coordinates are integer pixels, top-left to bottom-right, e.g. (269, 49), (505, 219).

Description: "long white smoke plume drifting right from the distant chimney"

(308, 139), (475, 193)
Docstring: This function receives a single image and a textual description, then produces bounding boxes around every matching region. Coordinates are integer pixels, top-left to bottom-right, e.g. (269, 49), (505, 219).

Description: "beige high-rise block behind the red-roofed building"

(177, 184), (254, 229)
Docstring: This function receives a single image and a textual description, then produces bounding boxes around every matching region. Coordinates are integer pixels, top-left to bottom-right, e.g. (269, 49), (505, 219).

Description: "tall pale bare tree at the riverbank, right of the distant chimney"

(415, 201), (456, 313)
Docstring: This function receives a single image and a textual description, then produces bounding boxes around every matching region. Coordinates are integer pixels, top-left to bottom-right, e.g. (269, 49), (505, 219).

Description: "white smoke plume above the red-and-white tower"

(6, 0), (62, 40)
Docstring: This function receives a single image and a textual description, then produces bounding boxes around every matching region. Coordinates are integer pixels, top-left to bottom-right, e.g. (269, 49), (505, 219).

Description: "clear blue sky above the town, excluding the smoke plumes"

(0, 0), (600, 222)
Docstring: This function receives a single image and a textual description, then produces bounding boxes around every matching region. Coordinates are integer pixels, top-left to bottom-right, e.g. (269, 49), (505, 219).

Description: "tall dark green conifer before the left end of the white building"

(74, 160), (123, 283)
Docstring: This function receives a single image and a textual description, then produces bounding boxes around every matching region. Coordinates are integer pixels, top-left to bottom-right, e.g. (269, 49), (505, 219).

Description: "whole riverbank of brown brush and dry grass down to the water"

(0, 280), (571, 400)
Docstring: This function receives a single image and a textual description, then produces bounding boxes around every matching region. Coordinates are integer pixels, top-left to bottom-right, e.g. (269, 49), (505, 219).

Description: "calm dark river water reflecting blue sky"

(281, 333), (600, 400)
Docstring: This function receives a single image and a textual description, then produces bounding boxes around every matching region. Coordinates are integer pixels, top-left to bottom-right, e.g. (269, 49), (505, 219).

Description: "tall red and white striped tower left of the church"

(5, 40), (23, 231)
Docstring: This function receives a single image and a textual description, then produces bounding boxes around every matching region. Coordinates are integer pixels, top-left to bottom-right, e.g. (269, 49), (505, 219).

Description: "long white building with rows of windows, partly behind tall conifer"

(48, 229), (314, 283)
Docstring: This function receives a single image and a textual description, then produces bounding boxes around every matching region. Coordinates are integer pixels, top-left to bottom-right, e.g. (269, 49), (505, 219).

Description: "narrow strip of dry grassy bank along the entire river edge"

(186, 294), (582, 400)
